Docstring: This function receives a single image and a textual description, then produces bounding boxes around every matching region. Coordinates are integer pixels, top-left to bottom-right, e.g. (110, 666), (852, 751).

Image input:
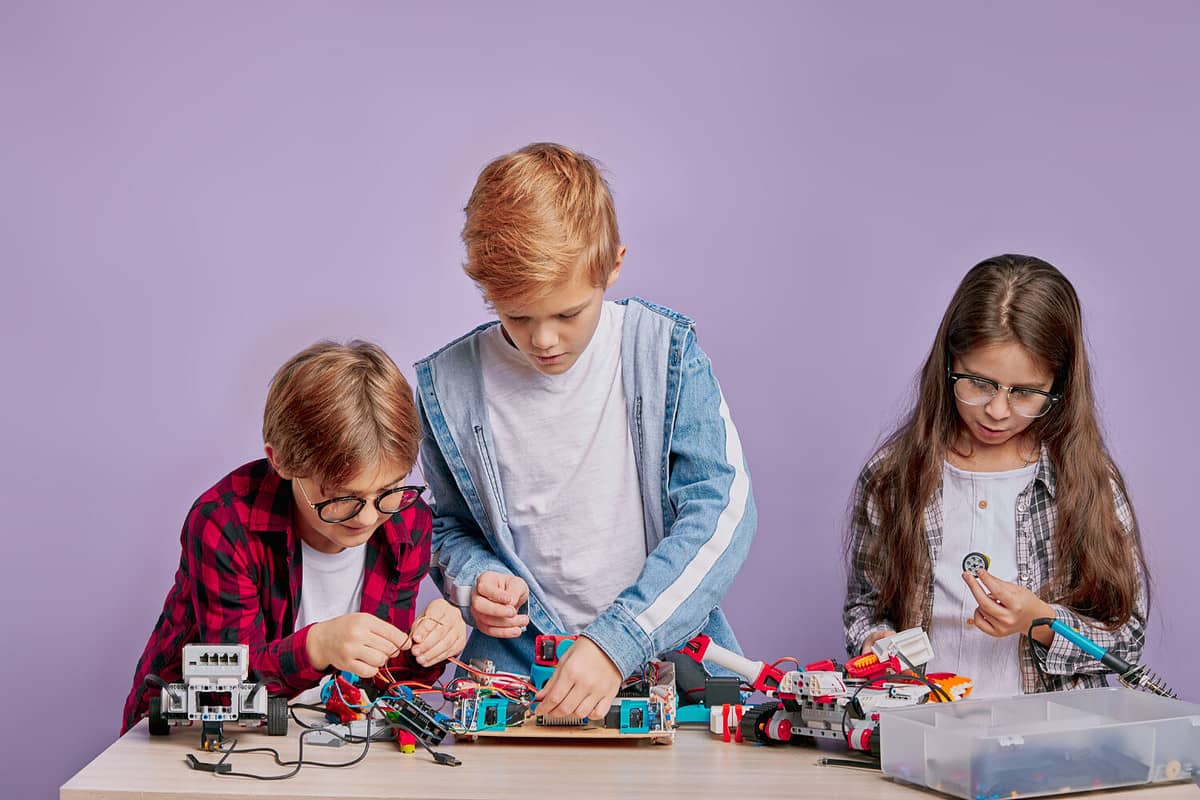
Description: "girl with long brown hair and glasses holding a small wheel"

(842, 255), (1150, 696)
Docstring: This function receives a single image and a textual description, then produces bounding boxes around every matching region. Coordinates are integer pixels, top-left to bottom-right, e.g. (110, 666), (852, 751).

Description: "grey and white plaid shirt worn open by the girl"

(842, 447), (1146, 693)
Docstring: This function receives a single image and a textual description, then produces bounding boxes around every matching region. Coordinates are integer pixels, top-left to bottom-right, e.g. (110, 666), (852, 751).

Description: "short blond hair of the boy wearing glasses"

(263, 339), (420, 488)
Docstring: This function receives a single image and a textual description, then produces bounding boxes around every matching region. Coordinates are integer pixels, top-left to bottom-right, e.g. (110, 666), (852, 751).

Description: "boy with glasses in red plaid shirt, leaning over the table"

(121, 342), (467, 733)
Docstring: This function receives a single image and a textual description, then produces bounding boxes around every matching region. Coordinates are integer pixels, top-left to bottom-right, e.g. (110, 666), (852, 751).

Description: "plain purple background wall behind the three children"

(0, 0), (1200, 798)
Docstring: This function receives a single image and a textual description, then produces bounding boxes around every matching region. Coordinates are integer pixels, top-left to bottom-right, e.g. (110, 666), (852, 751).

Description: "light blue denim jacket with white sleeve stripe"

(415, 297), (757, 675)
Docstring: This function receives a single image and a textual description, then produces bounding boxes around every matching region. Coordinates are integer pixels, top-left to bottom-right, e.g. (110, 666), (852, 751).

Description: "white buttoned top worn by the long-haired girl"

(928, 463), (1037, 697)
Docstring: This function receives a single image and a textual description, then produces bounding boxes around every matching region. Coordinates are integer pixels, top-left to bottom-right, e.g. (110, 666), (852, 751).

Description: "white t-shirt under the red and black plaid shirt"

(294, 540), (367, 703)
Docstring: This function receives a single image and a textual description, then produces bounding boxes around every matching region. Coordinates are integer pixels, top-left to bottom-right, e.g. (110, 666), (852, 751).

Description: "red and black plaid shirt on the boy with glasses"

(121, 458), (444, 733)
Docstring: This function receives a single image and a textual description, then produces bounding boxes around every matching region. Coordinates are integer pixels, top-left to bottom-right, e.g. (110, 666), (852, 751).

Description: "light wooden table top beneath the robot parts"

(59, 721), (1200, 800)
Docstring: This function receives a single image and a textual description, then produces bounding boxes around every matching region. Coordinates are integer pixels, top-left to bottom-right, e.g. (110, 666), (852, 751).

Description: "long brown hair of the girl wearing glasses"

(853, 255), (1150, 630)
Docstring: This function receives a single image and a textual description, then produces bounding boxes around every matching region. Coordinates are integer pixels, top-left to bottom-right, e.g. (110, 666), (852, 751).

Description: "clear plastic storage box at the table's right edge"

(880, 688), (1200, 800)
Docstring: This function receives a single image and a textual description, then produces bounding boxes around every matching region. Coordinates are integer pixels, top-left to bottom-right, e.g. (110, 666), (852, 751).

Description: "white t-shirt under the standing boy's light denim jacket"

(480, 302), (646, 633)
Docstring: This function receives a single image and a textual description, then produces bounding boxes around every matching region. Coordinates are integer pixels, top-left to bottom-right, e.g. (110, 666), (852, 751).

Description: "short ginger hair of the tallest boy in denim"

(462, 143), (620, 306)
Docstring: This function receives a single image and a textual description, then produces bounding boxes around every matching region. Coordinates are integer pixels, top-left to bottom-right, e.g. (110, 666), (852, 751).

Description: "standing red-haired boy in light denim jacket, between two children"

(416, 144), (756, 717)
